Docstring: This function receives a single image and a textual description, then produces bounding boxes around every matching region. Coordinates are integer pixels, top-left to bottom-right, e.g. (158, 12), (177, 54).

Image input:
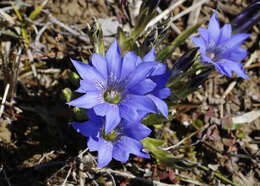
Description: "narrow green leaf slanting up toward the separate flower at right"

(157, 23), (201, 61)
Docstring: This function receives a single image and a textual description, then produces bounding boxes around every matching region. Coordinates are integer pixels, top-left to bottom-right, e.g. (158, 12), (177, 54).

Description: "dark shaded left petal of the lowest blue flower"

(72, 121), (102, 137)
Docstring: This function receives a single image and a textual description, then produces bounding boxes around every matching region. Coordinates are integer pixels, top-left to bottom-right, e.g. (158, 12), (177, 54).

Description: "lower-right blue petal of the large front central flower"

(125, 94), (157, 113)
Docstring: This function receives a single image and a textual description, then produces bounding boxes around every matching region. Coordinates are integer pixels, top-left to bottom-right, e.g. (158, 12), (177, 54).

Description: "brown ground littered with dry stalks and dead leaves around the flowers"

(0, 0), (260, 186)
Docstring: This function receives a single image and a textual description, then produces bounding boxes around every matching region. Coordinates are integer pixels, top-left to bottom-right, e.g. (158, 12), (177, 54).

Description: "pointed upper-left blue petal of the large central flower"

(71, 59), (105, 84)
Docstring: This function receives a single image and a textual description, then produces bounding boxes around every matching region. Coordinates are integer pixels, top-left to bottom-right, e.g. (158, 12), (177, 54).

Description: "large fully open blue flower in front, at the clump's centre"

(68, 41), (169, 133)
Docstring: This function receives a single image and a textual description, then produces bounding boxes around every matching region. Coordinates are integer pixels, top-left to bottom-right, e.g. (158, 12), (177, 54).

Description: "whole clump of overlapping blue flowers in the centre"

(68, 41), (171, 167)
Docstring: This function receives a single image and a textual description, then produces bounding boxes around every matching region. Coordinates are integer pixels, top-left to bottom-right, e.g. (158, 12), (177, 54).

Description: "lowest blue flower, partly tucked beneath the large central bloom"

(72, 109), (151, 167)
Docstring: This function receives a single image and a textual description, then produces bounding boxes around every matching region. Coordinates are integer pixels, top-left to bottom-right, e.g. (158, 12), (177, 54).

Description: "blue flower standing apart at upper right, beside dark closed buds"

(191, 13), (249, 79)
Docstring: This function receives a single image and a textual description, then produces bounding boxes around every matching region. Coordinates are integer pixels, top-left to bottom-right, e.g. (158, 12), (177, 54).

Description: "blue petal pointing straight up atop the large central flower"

(106, 40), (122, 79)
